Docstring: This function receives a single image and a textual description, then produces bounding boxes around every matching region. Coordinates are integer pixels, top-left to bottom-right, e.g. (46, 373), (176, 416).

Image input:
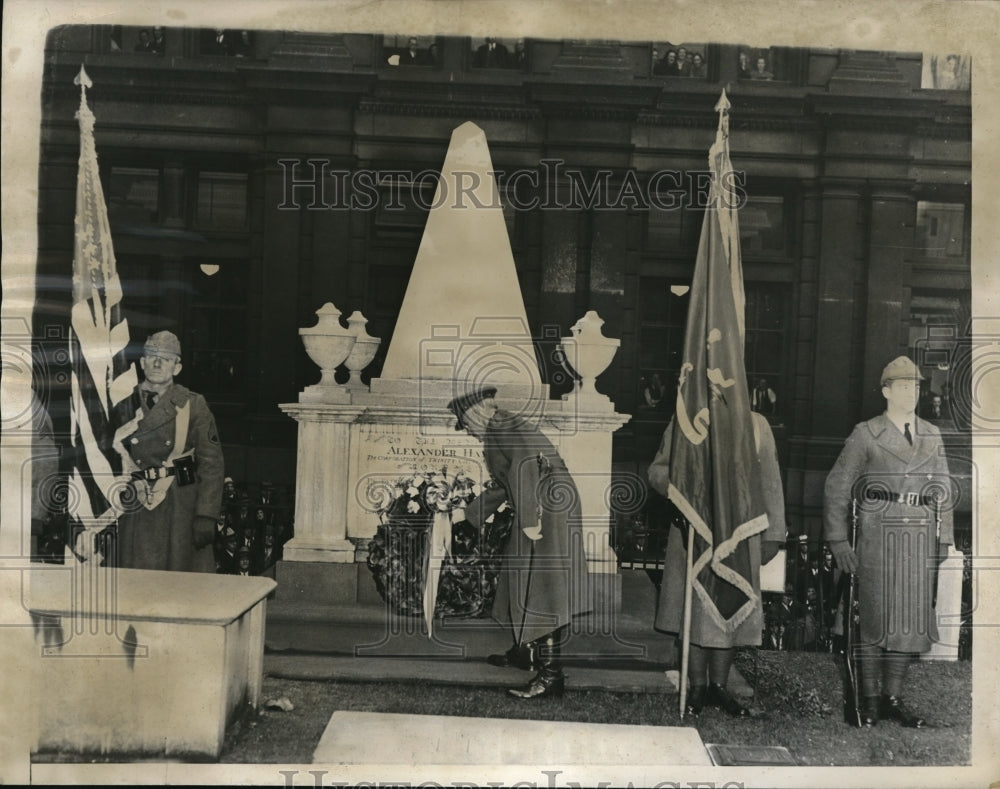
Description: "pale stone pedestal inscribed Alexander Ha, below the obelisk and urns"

(280, 390), (629, 574)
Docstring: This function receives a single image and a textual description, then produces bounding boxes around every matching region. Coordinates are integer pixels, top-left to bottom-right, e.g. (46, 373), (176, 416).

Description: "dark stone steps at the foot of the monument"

(264, 603), (752, 695)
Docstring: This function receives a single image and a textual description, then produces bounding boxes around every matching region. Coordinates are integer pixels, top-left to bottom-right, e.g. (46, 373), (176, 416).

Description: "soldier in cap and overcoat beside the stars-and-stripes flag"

(116, 331), (224, 573)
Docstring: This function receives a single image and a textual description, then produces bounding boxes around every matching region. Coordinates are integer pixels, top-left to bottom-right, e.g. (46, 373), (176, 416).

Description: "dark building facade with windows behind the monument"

(34, 26), (972, 564)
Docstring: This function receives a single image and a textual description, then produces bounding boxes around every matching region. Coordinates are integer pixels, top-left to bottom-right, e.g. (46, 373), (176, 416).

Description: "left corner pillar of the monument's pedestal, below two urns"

(281, 403), (361, 563)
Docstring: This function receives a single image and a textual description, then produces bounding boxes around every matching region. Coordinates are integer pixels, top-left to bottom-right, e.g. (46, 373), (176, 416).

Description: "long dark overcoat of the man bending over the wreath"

(483, 410), (590, 644)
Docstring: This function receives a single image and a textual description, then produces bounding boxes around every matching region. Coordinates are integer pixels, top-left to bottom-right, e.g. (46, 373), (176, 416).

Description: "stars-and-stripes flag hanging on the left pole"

(69, 67), (138, 556)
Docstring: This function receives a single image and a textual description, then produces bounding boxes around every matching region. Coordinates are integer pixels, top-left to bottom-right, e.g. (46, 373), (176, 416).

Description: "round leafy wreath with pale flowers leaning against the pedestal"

(367, 468), (514, 617)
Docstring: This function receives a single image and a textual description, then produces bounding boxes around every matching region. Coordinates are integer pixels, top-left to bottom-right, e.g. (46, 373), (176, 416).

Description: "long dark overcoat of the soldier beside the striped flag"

(117, 384), (224, 573)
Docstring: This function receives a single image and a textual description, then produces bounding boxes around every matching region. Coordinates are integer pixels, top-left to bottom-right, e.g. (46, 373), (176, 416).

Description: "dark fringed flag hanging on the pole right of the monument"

(669, 92), (767, 632)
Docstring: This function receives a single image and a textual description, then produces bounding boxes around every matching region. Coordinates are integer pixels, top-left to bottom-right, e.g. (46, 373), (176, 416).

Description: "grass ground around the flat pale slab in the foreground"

(220, 650), (972, 766)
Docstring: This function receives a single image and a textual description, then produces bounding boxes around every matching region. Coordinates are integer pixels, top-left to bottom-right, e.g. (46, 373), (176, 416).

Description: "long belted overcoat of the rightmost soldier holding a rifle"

(823, 414), (954, 652)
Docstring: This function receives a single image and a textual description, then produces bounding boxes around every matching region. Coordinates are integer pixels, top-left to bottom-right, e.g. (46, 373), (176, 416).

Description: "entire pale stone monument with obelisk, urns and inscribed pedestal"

(278, 123), (629, 616)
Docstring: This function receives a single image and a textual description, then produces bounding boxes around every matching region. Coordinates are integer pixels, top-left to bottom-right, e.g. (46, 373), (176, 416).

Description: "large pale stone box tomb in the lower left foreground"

(29, 565), (275, 759)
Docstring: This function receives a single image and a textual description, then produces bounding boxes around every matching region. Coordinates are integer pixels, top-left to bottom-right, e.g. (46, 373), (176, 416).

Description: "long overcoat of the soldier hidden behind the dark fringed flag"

(649, 413), (786, 647)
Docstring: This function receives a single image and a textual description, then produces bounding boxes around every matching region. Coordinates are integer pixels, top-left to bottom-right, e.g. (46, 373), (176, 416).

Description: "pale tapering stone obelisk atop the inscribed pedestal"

(371, 123), (548, 401)
